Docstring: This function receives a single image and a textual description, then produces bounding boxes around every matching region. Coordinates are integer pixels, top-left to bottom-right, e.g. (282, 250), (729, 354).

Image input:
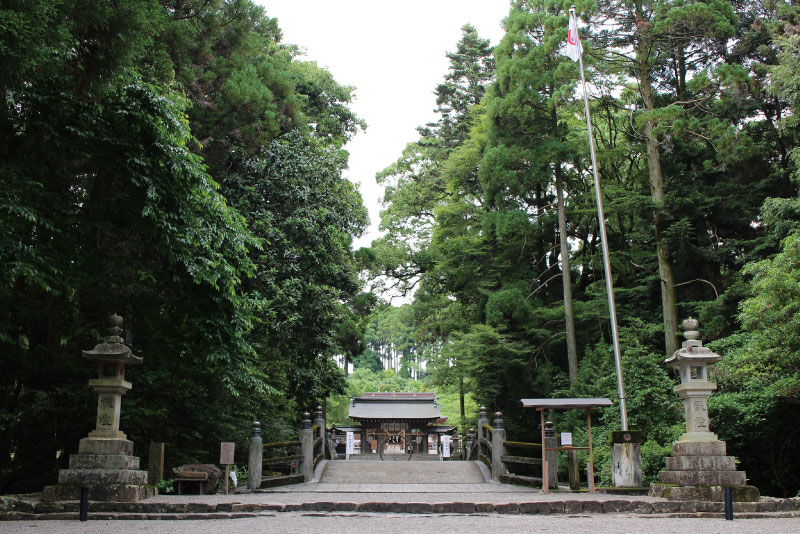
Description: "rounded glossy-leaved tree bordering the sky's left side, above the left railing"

(220, 133), (367, 401)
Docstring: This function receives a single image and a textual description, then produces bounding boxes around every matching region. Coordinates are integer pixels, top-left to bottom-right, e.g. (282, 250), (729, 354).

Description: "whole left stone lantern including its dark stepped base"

(43, 314), (155, 502)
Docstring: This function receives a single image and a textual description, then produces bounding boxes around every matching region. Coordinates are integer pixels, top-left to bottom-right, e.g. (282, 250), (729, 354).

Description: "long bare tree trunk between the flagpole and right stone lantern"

(636, 12), (678, 355)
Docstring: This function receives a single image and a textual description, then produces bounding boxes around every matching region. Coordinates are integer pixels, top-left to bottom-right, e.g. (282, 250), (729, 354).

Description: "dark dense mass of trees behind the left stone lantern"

(0, 0), (366, 492)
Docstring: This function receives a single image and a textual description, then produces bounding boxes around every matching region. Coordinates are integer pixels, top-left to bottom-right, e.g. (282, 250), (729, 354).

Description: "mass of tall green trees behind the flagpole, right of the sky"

(363, 0), (800, 496)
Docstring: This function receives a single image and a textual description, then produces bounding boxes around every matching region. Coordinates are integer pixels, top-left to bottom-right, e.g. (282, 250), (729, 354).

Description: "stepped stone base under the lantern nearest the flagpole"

(650, 440), (760, 502)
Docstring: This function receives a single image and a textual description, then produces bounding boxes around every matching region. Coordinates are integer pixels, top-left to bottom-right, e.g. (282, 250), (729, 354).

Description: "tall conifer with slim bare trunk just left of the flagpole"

(482, 1), (578, 383)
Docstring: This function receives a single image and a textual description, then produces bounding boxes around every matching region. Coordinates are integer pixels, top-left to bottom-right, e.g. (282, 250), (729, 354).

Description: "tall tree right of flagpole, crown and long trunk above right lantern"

(598, 0), (736, 354)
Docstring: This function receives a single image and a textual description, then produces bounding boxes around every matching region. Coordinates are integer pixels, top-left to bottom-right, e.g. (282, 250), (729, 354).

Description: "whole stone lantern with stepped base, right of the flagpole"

(650, 318), (760, 501)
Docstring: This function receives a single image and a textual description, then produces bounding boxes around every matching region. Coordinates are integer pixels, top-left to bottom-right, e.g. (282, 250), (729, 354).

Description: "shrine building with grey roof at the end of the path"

(334, 392), (456, 457)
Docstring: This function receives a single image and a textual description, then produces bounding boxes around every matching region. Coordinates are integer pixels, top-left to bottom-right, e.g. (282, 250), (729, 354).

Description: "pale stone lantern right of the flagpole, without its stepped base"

(664, 318), (722, 441)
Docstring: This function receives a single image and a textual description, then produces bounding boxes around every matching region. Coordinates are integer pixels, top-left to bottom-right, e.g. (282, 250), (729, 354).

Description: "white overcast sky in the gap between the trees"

(255, 0), (509, 248)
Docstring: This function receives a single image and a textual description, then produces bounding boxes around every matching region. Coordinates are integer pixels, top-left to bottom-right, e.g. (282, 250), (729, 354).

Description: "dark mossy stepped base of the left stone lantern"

(42, 438), (158, 502)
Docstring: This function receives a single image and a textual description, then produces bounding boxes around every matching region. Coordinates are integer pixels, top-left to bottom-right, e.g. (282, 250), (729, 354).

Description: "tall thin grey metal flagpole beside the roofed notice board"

(569, 6), (628, 431)
